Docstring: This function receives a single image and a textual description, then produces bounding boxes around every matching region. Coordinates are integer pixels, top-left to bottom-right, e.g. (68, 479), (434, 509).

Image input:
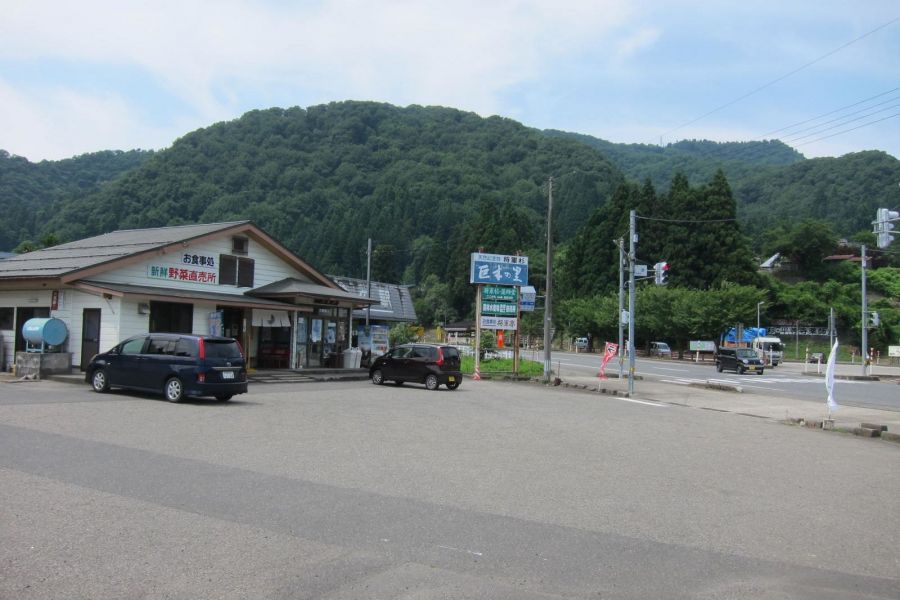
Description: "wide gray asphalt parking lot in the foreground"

(0, 381), (900, 599)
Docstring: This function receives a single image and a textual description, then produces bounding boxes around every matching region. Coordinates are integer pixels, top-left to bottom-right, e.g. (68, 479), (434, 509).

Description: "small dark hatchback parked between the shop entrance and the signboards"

(369, 344), (462, 390)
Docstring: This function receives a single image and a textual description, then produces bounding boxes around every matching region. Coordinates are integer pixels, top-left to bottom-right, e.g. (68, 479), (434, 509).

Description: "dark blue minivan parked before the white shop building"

(85, 333), (247, 402)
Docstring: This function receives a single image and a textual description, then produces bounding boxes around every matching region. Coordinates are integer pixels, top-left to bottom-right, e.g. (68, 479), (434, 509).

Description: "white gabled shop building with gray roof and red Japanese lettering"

(0, 221), (378, 370)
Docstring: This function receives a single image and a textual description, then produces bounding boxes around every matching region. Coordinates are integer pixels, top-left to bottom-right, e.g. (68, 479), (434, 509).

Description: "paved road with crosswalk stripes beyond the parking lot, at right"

(553, 352), (900, 411)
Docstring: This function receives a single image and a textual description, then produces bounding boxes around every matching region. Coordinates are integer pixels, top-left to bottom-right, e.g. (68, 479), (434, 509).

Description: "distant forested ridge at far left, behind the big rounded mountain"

(0, 150), (153, 250)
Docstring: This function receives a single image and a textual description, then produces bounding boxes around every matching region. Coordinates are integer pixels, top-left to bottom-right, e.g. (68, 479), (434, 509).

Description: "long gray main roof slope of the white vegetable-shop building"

(0, 221), (249, 277)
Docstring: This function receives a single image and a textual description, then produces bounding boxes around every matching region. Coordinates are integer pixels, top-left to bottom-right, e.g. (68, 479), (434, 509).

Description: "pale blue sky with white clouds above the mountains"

(0, 0), (900, 162)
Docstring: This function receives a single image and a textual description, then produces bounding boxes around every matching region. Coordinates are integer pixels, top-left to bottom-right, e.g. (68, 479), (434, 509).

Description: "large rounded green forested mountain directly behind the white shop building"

(37, 102), (624, 283)
